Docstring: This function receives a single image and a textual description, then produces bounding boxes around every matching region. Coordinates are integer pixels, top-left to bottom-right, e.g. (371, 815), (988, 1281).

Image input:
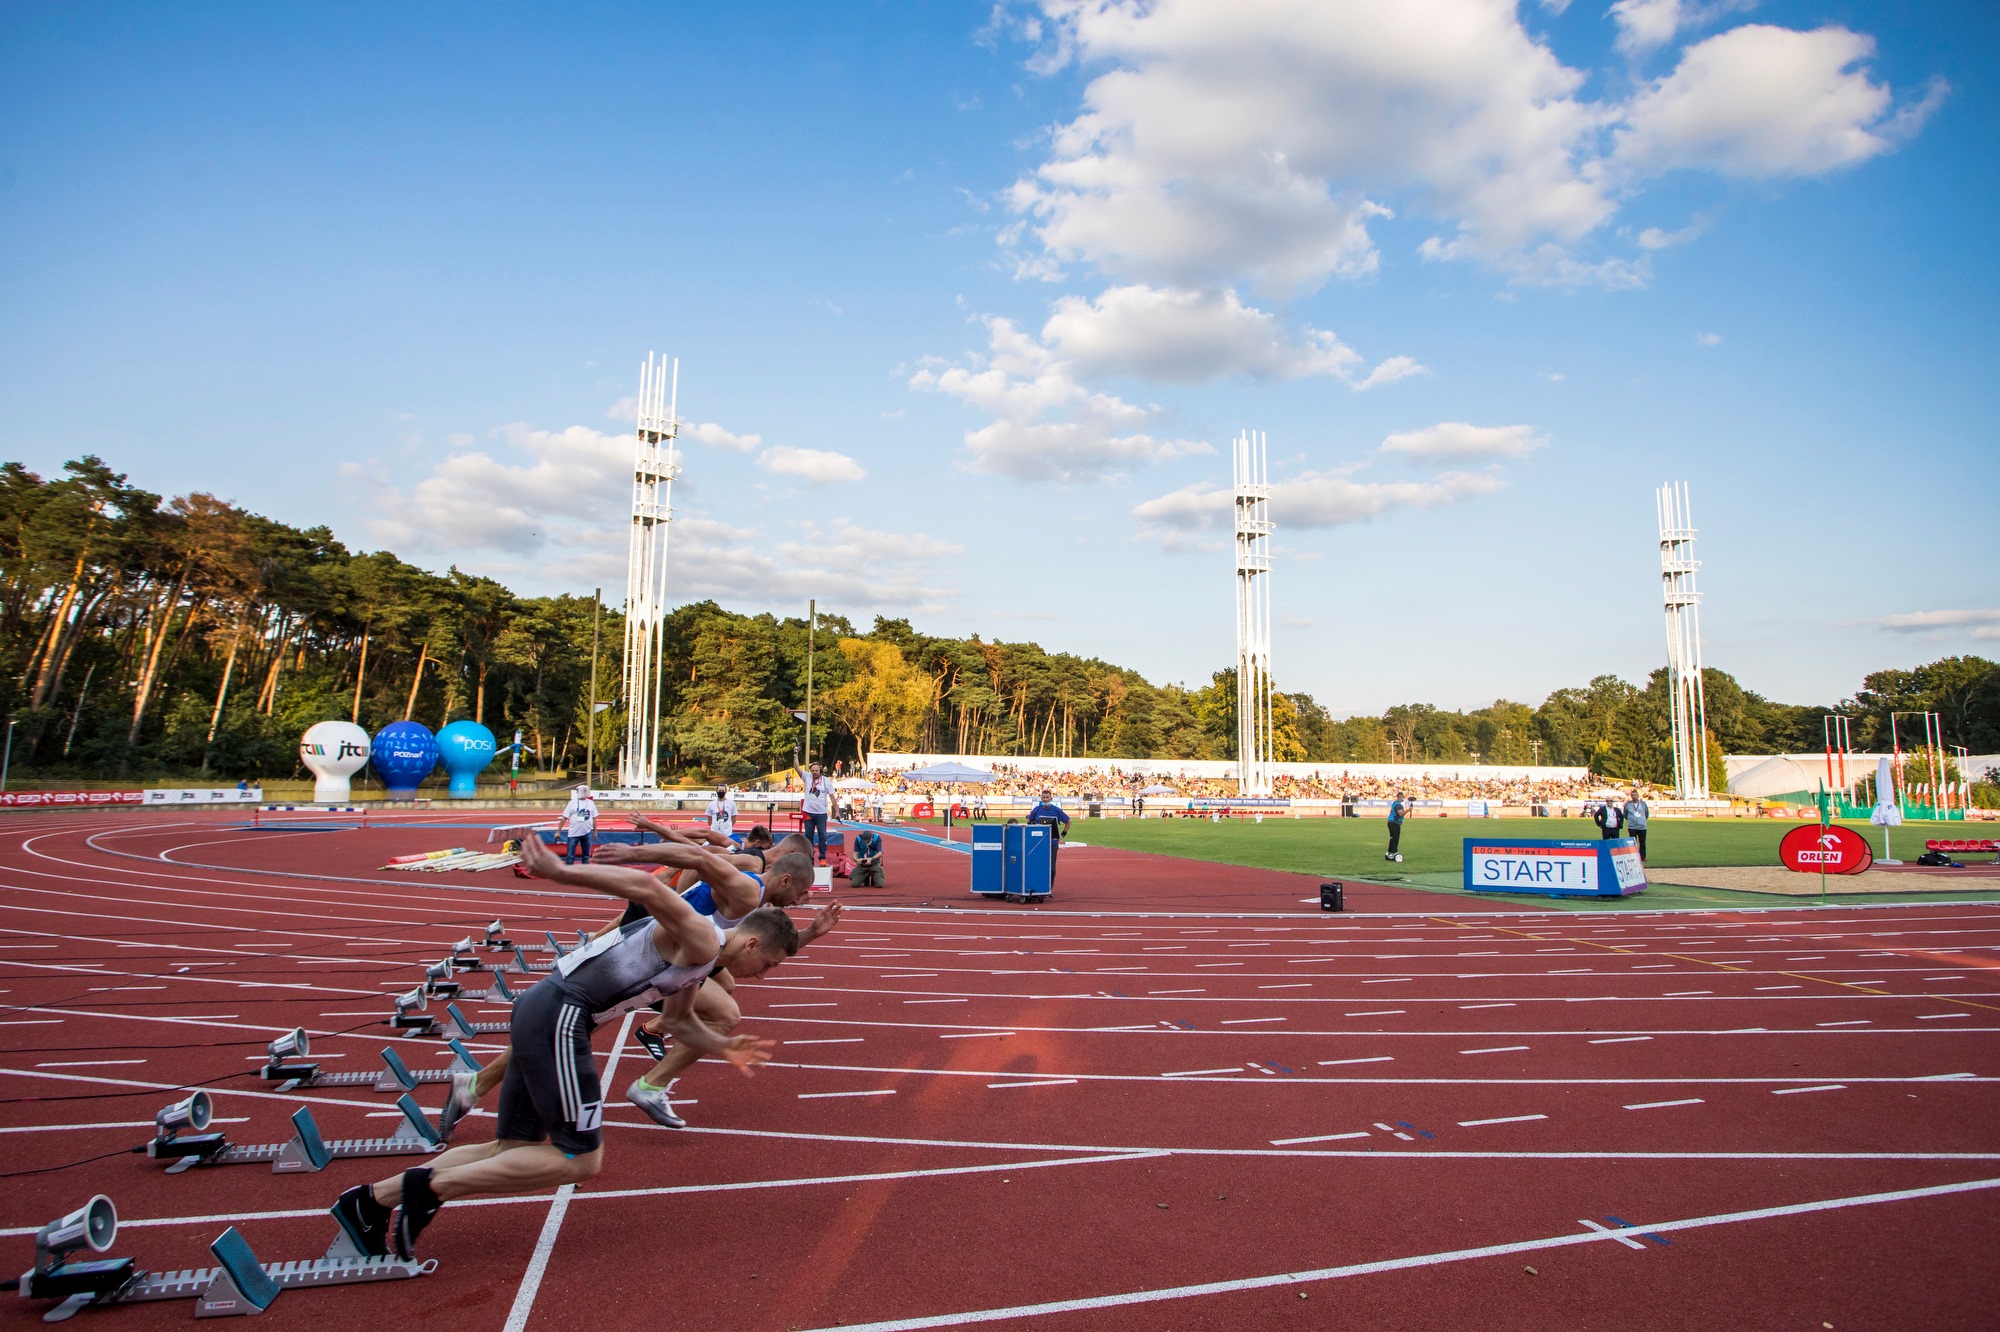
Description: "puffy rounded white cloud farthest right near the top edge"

(1614, 24), (1946, 176)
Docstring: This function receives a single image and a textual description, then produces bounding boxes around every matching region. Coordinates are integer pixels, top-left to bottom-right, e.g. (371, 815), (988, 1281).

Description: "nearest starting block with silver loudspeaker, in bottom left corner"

(20, 1194), (438, 1322)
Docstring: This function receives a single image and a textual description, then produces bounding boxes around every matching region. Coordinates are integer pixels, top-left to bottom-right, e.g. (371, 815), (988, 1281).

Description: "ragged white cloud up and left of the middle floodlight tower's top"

(910, 316), (1214, 482)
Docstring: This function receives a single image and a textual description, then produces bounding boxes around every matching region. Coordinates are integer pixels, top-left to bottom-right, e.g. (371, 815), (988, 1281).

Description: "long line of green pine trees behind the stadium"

(0, 456), (2000, 782)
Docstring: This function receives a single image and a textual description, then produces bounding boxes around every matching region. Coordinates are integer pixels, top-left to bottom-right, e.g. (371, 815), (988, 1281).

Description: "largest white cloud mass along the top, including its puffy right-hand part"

(994, 0), (1944, 294)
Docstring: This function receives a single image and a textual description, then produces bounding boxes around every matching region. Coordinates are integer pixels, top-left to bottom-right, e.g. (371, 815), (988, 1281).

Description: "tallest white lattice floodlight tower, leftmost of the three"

(618, 352), (680, 790)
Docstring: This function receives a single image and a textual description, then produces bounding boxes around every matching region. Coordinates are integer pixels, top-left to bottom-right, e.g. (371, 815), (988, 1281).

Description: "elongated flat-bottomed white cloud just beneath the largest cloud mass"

(1042, 284), (1424, 388)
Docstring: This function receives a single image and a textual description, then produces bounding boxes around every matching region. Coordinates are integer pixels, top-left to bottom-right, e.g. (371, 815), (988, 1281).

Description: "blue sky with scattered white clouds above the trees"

(0, 0), (2000, 714)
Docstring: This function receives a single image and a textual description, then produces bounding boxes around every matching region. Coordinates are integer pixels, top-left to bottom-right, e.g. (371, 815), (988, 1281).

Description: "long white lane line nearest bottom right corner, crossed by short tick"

(776, 1180), (2000, 1332)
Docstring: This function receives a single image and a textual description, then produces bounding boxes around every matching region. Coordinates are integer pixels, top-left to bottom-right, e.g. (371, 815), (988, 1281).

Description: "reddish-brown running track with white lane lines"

(0, 812), (2000, 1332)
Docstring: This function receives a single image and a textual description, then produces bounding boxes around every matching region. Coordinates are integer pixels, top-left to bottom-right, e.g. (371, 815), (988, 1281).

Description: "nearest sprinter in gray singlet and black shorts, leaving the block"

(332, 838), (798, 1258)
